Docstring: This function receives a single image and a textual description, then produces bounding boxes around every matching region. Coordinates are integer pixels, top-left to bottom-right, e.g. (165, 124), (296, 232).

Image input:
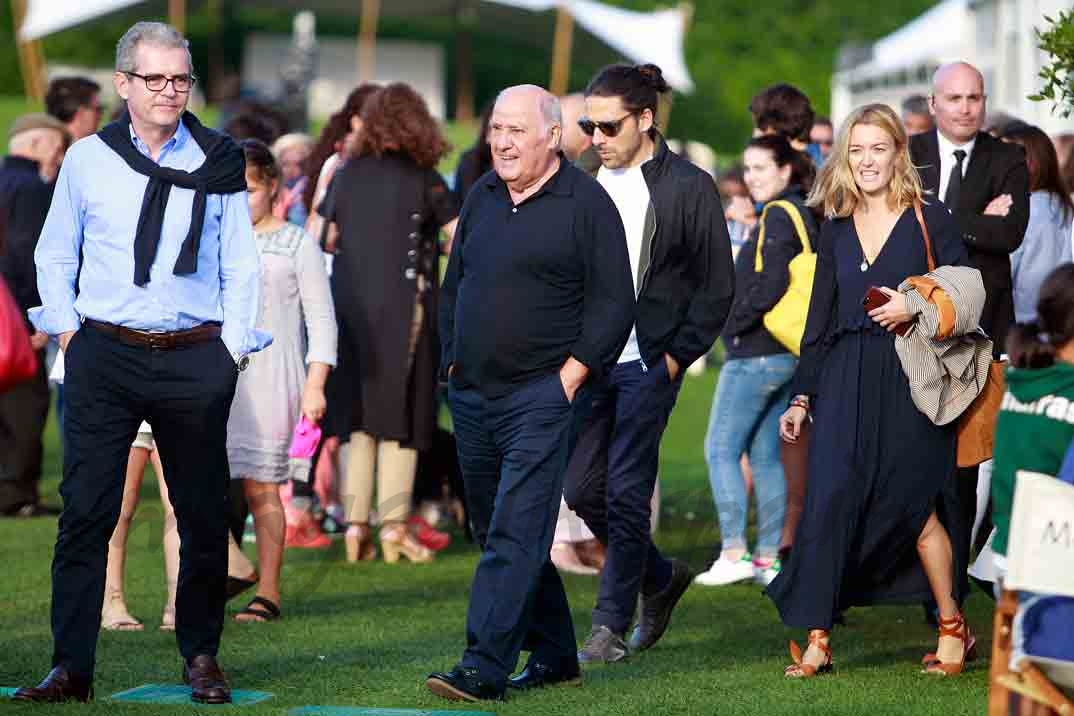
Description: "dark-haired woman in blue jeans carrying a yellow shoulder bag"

(695, 135), (817, 586)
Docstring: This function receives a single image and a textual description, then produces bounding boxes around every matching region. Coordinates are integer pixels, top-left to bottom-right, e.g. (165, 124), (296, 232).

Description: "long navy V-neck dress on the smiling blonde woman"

(768, 204), (967, 629)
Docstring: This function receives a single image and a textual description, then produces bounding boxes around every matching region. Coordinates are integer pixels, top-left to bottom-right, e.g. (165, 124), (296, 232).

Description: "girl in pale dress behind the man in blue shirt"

(228, 140), (336, 622)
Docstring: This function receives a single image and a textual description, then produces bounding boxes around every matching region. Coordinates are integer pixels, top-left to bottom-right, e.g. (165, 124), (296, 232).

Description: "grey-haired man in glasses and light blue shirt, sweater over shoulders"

(15, 23), (271, 703)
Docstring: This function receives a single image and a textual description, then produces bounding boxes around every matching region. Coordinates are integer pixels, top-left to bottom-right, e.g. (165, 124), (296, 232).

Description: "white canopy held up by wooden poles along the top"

(18, 0), (694, 92)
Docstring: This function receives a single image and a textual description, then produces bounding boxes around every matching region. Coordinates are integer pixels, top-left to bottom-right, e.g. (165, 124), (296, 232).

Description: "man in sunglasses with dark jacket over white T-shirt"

(566, 64), (735, 663)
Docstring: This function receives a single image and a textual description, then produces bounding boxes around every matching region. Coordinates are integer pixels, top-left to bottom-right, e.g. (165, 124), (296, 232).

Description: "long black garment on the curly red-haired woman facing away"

(321, 154), (459, 450)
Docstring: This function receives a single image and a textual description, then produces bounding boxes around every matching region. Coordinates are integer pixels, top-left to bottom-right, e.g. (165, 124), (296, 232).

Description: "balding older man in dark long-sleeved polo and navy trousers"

(426, 86), (634, 701)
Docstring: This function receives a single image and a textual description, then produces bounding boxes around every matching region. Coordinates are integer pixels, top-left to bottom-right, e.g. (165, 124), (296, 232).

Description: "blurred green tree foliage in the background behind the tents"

(0, 0), (933, 152)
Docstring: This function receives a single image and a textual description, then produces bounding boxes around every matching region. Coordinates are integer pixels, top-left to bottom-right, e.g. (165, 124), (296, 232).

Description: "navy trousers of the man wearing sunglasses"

(564, 359), (681, 634)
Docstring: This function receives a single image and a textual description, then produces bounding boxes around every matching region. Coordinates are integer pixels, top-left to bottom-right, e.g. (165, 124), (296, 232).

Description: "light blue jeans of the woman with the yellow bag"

(705, 353), (798, 557)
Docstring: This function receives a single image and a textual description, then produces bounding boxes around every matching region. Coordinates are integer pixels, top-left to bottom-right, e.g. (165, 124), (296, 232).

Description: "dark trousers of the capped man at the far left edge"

(0, 351), (50, 514)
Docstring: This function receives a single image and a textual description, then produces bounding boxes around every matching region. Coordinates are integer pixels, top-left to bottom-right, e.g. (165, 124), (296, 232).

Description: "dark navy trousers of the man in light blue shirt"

(53, 325), (238, 677)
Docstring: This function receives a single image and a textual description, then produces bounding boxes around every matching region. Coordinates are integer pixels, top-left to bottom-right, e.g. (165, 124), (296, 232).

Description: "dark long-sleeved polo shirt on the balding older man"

(440, 156), (635, 397)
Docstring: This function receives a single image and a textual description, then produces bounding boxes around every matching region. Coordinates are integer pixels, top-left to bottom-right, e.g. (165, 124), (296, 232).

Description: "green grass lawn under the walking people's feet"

(0, 370), (991, 716)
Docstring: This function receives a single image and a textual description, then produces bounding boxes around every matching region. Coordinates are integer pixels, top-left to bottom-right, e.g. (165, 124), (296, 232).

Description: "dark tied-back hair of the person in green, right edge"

(1006, 263), (1074, 368)
